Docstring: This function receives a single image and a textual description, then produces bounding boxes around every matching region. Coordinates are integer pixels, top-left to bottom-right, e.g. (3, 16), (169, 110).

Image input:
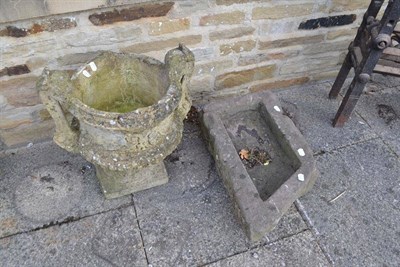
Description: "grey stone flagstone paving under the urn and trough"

(0, 77), (400, 267)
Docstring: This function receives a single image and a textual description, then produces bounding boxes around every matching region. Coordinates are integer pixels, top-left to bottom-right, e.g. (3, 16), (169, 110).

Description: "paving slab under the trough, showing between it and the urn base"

(134, 128), (306, 266)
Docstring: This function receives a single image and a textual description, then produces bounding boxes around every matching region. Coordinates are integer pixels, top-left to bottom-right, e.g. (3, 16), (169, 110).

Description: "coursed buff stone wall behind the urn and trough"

(0, 0), (370, 147)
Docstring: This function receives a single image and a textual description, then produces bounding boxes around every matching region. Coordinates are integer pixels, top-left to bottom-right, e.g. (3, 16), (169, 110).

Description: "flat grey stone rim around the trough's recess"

(203, 91), (318, 241)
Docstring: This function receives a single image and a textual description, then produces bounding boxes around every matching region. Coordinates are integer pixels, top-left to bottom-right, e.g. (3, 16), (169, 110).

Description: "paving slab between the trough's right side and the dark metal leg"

(276, 83), (376, 153)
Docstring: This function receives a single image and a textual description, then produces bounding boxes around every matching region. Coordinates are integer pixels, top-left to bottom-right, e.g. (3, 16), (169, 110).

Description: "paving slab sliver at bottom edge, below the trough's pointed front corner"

(207, 231), (330, 267)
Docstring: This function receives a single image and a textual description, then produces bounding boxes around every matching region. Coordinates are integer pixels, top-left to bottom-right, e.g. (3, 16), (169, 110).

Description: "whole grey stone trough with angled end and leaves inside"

(202, 92), (318, 241)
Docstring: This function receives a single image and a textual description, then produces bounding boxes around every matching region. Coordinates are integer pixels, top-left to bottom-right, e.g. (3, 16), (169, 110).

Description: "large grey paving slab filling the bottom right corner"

(297, 139), (400, 266)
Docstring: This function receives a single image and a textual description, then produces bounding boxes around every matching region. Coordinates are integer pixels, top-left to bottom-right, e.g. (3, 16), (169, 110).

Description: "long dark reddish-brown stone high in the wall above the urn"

(89, 2), (174, 26)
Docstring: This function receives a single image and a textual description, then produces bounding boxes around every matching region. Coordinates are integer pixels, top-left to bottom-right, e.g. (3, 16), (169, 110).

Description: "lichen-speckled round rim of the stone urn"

(69, 51), (182, 129)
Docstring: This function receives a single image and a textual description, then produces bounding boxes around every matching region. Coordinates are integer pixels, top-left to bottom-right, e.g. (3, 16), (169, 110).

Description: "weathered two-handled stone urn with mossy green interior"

(37, 45), (194, 198)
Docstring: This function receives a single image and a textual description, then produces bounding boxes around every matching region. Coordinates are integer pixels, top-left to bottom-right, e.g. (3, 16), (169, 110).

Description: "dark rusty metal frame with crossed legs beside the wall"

(329, 0), (400, 127)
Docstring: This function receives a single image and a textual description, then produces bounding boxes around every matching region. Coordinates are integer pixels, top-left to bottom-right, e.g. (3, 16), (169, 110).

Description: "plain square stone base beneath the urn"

(96, 162), (168, 199)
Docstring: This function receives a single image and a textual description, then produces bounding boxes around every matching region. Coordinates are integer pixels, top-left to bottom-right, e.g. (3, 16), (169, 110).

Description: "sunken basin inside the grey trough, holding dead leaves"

(222, 107), (299, 201)
